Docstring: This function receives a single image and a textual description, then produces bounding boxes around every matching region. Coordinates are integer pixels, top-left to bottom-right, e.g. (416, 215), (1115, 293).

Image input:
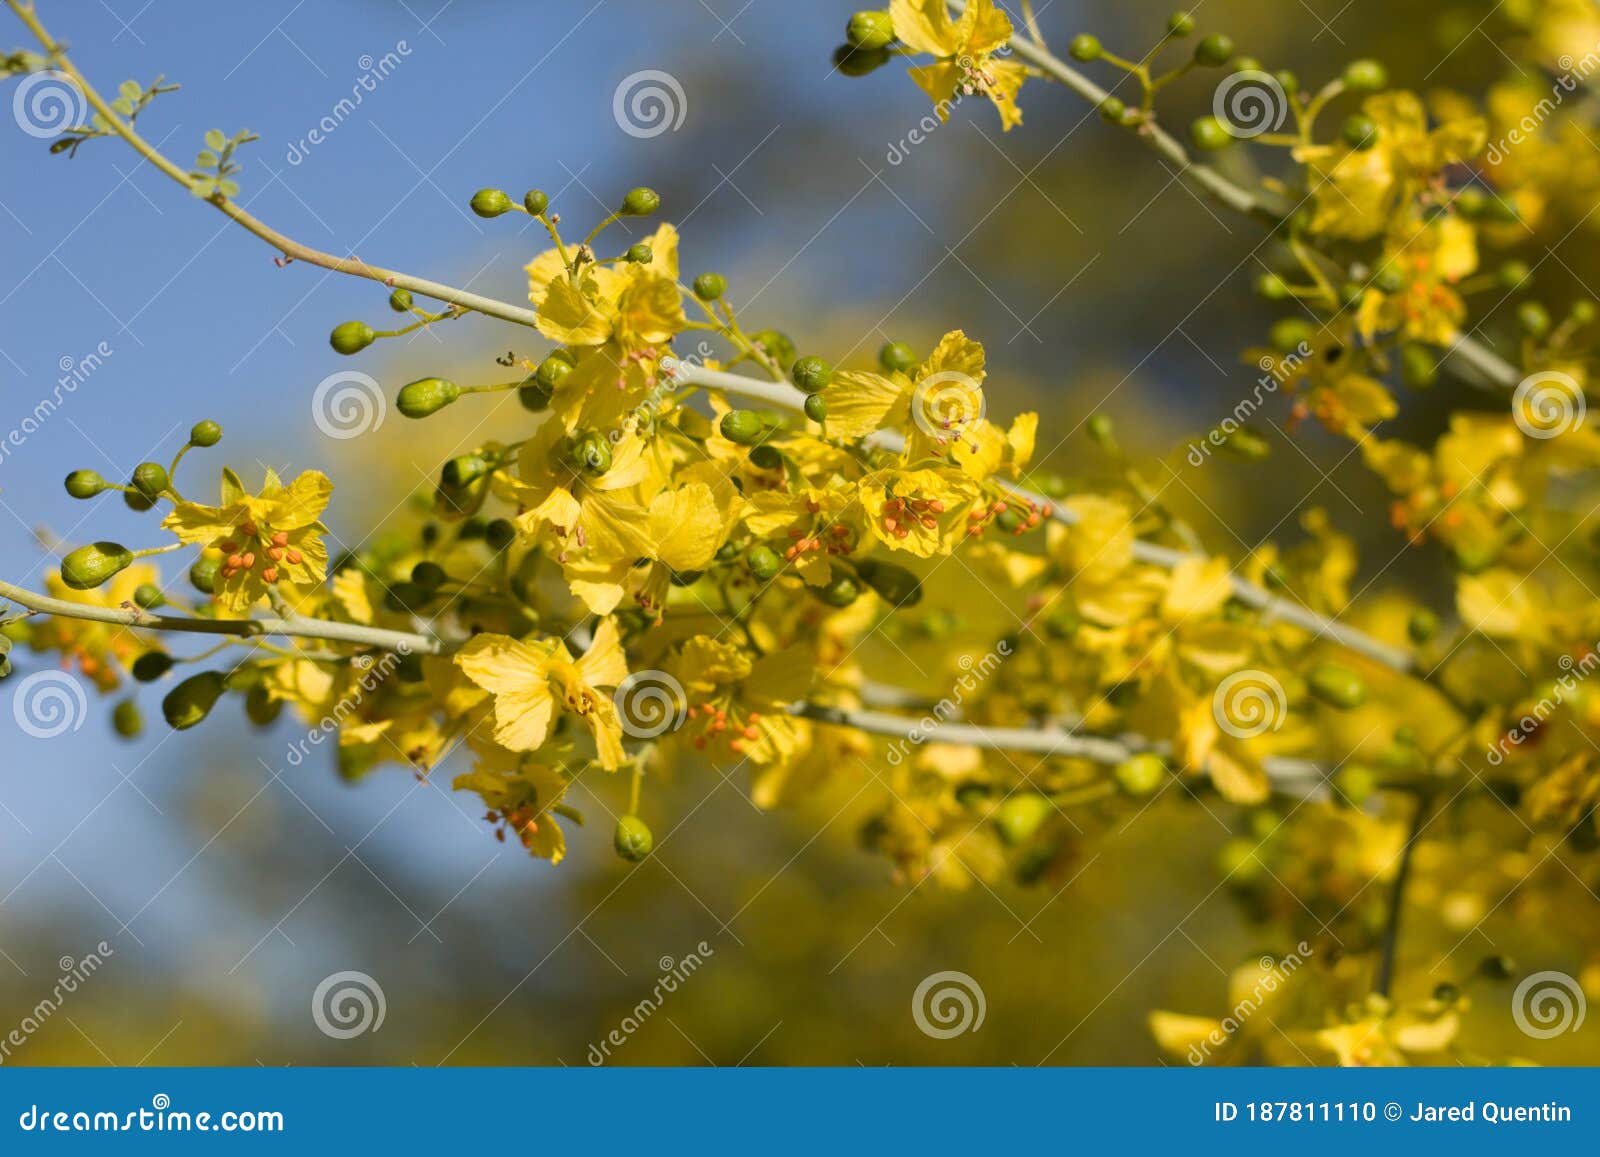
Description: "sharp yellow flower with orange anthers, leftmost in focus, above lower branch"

(162, 469), (333, 615)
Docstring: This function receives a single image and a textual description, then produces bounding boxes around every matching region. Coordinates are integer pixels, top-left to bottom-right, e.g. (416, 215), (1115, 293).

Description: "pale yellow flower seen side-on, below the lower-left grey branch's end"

(456, 619), (627, 771)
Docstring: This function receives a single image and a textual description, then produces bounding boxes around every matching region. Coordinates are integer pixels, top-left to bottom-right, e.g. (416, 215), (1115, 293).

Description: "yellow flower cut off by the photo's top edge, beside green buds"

(890, 0), (1027, 131)
